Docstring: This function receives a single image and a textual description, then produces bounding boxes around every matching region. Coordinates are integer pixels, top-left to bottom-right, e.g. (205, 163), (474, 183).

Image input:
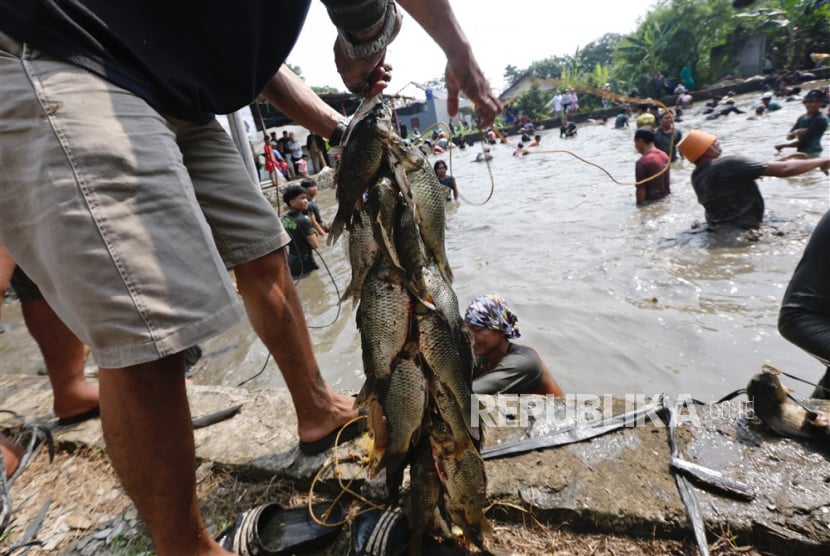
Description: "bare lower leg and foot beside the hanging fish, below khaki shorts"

(234, 248), (357, 442)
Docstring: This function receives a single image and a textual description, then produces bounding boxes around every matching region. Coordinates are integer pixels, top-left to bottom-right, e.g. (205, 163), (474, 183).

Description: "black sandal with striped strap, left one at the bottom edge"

(217, 502), (346, 556)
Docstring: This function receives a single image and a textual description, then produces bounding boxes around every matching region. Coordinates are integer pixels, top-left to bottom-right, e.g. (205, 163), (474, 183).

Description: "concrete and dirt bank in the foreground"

(0, 364), (830, 556)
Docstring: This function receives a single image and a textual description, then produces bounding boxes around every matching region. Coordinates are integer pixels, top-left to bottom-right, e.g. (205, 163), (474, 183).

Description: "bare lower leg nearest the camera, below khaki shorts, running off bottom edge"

(100, 354), (228, 556)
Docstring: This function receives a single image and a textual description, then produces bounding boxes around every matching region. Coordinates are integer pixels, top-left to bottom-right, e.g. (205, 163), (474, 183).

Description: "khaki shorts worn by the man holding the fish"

(0, 33), (289, 368)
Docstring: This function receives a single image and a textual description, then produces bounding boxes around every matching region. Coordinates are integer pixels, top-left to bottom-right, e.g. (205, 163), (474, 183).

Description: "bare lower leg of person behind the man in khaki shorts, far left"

(21, 298), (98, 418)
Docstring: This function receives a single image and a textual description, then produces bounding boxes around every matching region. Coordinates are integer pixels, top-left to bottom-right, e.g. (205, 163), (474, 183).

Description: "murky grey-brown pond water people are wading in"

(203, 81), (830, 400)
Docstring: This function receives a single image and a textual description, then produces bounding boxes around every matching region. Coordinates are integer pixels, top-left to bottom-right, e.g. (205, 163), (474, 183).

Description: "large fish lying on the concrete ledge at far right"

(746, 370), (830, 441)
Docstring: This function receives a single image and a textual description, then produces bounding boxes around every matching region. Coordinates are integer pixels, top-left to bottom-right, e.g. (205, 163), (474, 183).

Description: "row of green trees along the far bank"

(505, 0), (830, 104)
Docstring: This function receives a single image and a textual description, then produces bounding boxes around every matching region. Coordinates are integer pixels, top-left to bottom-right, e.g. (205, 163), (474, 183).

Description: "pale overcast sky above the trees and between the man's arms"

(290, 0), (655, 93)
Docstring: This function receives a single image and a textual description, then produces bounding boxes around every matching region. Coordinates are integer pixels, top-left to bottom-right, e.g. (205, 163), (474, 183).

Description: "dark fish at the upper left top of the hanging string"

(328, 95), (392, 245)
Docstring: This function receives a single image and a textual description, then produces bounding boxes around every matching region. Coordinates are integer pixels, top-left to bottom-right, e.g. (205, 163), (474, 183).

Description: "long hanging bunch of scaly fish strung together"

(328, 97), (491, 553)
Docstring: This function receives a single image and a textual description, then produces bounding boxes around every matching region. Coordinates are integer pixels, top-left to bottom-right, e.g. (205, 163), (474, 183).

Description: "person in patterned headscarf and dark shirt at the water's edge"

(464, 294), (565, 397)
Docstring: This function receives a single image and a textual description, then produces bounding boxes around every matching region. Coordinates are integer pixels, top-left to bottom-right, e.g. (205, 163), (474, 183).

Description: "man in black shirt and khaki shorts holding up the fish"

(0, 0), (501, 555)
